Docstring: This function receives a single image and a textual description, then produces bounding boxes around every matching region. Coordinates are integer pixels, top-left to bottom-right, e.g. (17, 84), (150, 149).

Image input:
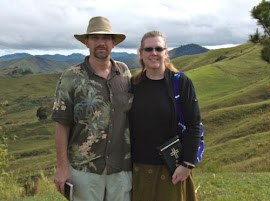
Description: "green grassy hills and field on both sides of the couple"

(0, 43), (270, 200)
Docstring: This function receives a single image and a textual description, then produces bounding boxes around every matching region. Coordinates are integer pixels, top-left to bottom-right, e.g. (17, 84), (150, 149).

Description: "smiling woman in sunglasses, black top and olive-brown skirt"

(130, 31), (201, 201)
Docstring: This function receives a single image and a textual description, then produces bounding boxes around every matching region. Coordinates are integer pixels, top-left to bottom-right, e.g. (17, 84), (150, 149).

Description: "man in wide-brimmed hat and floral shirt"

(52, 17), (132, 201)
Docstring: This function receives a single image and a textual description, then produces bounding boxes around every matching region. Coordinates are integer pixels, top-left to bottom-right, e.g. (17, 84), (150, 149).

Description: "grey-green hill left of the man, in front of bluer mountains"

(0, 56), (73, 73)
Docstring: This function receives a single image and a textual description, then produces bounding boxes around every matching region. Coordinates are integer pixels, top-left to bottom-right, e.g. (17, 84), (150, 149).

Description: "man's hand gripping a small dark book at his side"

(54, 167), (70, 195)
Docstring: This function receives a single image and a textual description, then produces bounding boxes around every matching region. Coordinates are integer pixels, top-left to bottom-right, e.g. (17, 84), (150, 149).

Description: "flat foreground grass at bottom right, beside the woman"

(194, 172), (270, 201)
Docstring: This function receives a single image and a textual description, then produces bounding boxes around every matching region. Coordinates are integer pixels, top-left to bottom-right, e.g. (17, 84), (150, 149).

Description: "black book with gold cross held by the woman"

(157, 135), (182, 175)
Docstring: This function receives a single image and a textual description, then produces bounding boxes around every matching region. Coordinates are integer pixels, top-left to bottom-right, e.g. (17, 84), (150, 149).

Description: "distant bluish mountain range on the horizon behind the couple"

(0, 44), (208, 75)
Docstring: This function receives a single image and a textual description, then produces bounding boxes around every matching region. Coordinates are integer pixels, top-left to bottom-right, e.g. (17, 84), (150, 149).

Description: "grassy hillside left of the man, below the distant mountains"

(0, 74), (60, 177)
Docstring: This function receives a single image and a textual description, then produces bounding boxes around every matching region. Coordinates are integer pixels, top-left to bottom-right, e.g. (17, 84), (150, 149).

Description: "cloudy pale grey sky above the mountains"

(0, 0), (261, 56)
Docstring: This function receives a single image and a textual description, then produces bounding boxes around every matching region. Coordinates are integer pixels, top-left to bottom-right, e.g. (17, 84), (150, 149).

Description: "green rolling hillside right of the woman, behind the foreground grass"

(172, 43), (270, 171)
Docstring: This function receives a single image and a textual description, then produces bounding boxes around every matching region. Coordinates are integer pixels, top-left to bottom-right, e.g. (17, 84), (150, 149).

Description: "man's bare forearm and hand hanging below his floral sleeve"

(54, 123), (70, 194)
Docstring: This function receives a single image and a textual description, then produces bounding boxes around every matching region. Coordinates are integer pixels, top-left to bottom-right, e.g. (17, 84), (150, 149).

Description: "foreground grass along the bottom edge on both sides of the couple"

(0, 170), (270, 201)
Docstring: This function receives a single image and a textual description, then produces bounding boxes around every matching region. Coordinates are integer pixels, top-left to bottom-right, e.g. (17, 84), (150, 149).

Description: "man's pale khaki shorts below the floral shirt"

(69, 166), (132, 201)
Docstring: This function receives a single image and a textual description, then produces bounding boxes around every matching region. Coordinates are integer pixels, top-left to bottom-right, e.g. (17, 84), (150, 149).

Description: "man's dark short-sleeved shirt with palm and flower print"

(52, 56), (133, 174)
